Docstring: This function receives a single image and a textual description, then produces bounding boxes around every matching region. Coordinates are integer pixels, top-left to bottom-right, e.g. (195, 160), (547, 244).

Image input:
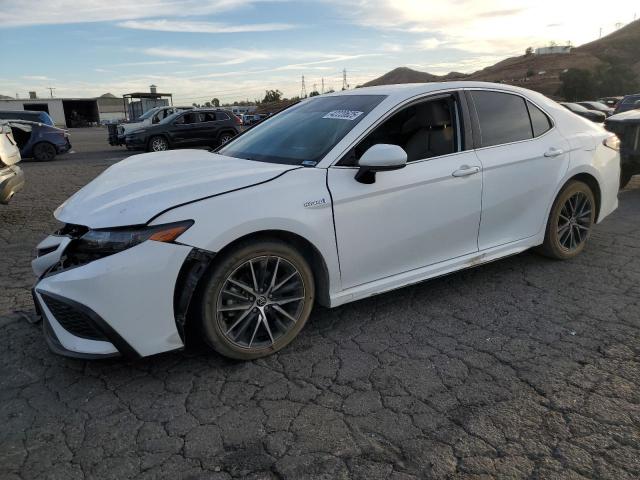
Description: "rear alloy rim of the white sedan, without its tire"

(557, 192), (593, 251)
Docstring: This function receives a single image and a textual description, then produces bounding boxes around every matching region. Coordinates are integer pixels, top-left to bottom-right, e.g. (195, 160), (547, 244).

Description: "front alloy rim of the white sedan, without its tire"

(216, 255), (305, 349)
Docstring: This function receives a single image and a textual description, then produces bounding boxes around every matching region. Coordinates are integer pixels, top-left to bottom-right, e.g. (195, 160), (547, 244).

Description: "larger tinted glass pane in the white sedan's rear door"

(471, 91), (533, 147)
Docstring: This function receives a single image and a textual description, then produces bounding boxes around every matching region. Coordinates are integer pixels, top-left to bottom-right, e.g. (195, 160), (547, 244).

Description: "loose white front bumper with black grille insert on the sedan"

(32, 235), (213, 358)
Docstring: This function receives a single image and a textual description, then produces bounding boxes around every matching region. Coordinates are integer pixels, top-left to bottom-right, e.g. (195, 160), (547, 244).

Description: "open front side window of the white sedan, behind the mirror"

(340, 97), (458, 166)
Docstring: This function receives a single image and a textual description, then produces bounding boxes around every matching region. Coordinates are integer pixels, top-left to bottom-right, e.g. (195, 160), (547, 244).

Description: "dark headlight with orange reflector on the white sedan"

(65, 220), (193, 263)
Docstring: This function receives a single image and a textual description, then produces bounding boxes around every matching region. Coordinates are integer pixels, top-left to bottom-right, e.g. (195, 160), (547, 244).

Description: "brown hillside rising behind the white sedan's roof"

(363, 20), (640, 97)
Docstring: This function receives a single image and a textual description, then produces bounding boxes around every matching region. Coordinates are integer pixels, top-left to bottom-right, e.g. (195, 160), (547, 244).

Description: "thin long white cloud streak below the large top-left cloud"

(118, 19), (297, 33)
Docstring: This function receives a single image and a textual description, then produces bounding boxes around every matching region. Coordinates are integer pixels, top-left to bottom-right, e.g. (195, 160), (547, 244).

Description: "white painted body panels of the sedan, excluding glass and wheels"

(34, 82), (620, 355)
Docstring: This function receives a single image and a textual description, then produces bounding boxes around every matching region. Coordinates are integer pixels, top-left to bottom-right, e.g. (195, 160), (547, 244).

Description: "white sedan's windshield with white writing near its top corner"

(218, 95), (385, 165)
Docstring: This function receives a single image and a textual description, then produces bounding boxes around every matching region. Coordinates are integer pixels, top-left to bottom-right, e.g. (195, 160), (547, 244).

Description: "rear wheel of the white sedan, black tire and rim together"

(537, 180), (596, 260)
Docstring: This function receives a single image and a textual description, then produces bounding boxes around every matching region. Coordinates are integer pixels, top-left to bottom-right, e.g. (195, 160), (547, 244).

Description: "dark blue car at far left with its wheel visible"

(8, 120), (71, 162)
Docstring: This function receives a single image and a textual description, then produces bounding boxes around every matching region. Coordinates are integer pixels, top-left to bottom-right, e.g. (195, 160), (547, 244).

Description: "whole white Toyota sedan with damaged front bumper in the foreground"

(33, 82), (620, 359)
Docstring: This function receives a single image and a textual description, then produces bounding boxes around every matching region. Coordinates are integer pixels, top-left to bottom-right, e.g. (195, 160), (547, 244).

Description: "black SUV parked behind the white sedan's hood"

(125, 110), (240, 152)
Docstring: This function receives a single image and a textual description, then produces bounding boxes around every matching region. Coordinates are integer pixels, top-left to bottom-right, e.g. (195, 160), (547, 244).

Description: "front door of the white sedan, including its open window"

(328, 97), (482, 288)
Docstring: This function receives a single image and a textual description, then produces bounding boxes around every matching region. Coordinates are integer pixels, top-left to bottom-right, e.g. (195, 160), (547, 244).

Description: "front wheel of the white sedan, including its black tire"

(200, 239), (315, 360)
